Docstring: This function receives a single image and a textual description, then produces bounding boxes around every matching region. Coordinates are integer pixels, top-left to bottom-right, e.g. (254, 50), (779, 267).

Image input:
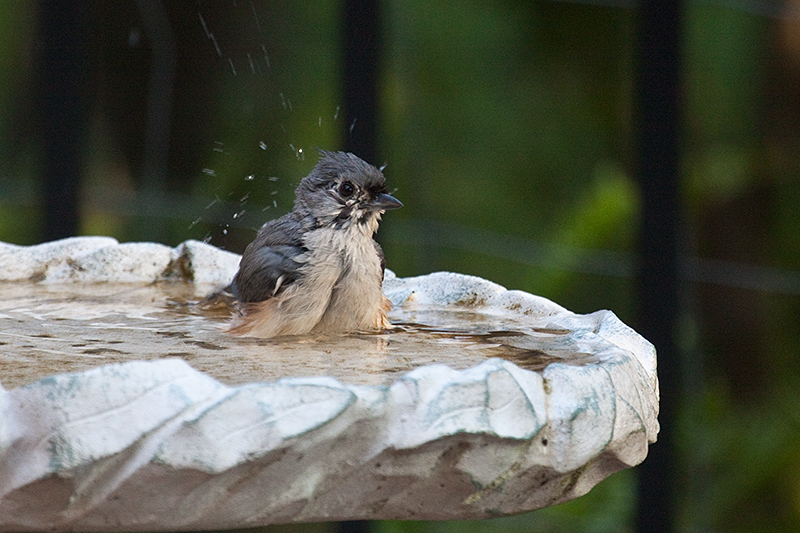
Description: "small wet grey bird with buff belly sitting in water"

(229, 150), (403, 338)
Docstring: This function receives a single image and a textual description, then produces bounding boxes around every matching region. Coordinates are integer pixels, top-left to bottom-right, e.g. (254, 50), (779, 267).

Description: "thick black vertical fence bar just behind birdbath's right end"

(636, 0), (682, 533)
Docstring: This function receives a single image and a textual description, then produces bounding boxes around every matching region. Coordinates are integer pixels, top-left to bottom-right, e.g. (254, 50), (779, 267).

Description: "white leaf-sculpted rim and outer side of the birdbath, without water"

(0, 237), (658, 531)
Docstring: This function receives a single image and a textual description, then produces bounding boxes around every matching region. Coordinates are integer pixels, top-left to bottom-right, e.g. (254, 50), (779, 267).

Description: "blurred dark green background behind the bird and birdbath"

(0, 0), (800, 533)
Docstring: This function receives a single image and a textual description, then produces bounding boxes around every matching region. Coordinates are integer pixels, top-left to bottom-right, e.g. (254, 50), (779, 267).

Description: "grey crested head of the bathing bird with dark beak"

(294, 150), (403, 234)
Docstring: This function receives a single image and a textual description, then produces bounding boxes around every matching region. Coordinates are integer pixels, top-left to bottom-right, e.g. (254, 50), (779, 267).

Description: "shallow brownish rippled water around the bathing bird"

(0, 282), (596, 389)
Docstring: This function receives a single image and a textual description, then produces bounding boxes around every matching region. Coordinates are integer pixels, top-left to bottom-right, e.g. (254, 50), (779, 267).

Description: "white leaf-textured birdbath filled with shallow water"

(0, 237), (658, 531)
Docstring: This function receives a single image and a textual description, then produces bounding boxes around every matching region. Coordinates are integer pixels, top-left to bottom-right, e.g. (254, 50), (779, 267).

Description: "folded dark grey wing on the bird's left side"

(231, 214), (308, 303)
